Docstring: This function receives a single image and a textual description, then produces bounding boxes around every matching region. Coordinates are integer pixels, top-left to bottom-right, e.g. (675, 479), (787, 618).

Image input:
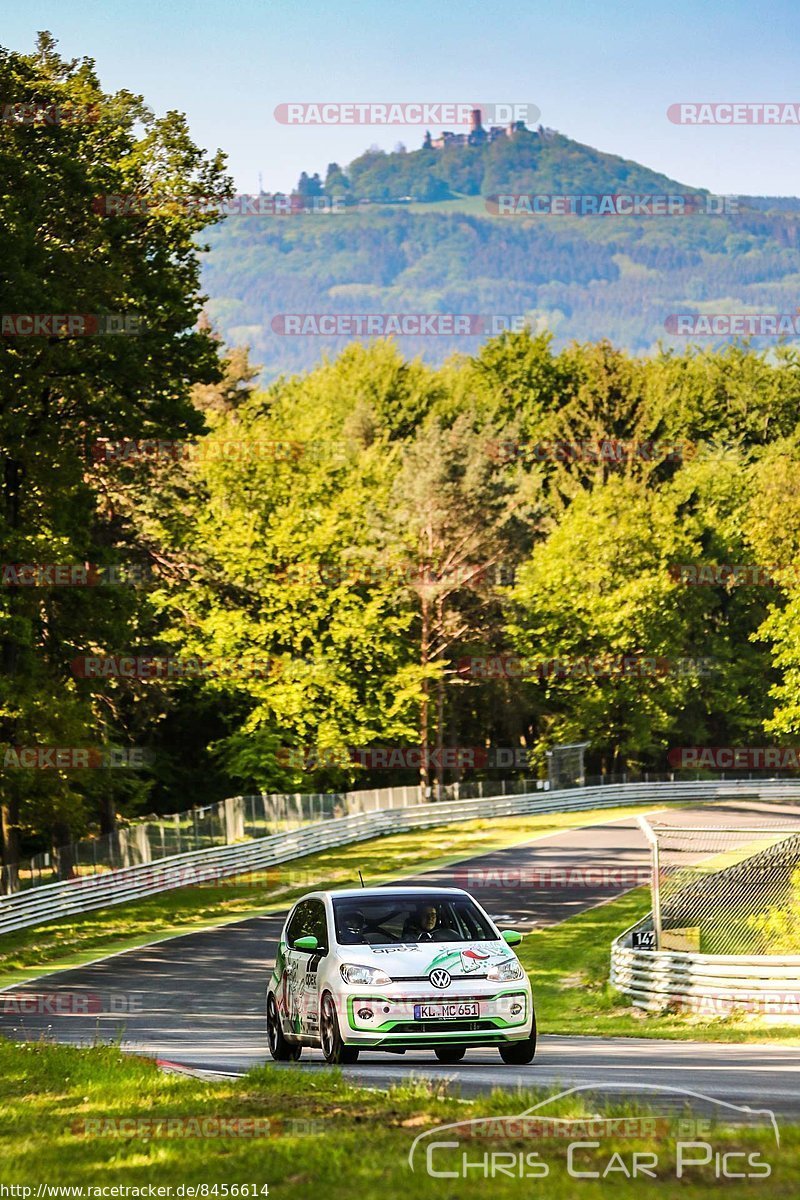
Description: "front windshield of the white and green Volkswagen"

(333, 892), (499, 946)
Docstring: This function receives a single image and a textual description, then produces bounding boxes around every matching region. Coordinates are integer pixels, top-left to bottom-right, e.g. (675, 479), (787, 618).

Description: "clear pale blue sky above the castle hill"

(6, 0), (800, 196)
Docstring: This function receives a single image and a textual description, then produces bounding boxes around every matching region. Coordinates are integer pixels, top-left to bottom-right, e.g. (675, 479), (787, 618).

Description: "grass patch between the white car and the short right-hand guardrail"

(517, 888), (800, 1043)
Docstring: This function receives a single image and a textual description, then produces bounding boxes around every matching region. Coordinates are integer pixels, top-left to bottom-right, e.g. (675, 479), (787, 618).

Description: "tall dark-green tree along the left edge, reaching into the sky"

(0, 34), (230, 889)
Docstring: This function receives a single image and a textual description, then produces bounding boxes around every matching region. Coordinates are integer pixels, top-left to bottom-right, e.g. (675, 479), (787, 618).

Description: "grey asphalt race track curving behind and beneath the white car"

(0, 802), (800, 1116)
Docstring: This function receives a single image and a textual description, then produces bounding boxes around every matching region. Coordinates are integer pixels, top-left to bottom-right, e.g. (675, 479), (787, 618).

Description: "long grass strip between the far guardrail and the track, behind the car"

(0, 802), (654, 986)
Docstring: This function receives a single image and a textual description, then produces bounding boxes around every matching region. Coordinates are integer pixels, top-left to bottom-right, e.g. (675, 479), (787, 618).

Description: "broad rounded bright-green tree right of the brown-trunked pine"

(509, 461), (769, 772)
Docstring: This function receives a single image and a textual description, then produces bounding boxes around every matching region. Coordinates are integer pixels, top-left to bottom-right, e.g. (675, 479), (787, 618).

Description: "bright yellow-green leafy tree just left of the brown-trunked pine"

(143, 343), (439, 791)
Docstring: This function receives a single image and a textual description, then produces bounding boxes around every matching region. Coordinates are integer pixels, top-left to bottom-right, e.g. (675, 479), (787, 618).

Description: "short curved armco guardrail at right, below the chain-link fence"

(610, 918), (800, 1016)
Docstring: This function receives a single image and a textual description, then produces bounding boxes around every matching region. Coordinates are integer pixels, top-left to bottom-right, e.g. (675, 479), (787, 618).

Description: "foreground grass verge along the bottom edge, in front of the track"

(0, 1039), (800, 1200)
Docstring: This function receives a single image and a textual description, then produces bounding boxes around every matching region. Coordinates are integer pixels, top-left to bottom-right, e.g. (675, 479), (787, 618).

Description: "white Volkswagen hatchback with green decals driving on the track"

(266, 887), (536, 1064)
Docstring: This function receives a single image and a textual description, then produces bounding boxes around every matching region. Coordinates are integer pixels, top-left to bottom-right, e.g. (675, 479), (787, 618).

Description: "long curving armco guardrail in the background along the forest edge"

(0, 780), (800, 935)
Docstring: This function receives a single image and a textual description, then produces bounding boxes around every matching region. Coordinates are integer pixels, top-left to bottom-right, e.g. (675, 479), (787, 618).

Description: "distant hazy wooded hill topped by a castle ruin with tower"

(203, 131), (800, 378)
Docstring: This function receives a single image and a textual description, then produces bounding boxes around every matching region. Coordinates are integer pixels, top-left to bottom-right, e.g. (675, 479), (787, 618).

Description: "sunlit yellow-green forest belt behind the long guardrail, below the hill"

(134, 334), (796, 790)
